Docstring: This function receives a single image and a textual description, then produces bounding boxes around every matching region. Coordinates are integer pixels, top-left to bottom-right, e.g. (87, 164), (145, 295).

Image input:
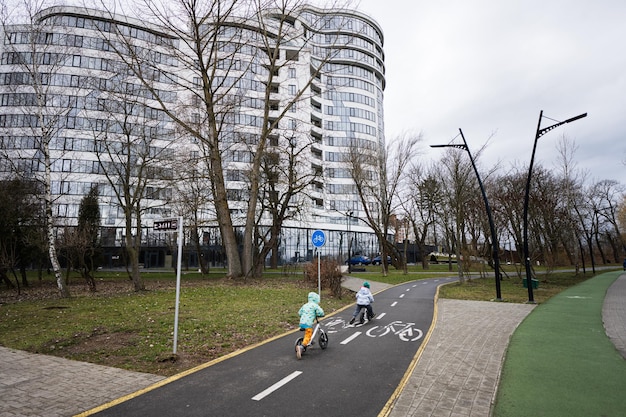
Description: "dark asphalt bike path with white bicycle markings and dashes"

(81, 277), (457, 417)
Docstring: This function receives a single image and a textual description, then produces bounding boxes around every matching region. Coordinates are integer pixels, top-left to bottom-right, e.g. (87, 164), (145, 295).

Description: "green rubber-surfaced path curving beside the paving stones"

(493, 272), (626, 417)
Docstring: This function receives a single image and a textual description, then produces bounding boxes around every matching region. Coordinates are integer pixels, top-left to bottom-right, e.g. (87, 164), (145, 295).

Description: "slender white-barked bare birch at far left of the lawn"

(1, 0), (76, 297)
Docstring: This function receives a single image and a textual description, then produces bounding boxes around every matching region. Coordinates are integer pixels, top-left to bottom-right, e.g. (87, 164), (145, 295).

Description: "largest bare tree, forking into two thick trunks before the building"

(97, 0), (358, 277)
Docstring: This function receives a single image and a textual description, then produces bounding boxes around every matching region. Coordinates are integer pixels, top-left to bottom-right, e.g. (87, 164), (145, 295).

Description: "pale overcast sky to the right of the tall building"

(357, 0), (626, 185)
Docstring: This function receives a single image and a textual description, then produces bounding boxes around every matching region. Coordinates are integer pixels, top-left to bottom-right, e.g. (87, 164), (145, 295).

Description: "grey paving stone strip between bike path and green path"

(389, 299), (535, 417)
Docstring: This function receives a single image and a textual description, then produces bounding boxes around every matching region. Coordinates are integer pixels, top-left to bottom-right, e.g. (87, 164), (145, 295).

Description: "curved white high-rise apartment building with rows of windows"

(0, 6), (385, 266)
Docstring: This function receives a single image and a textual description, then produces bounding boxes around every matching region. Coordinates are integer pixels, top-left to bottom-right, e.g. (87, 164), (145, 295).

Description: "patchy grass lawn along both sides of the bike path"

(0, 265), (616, 376)
